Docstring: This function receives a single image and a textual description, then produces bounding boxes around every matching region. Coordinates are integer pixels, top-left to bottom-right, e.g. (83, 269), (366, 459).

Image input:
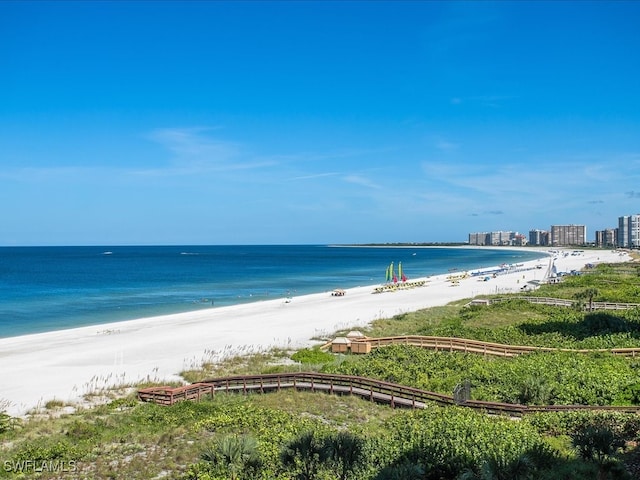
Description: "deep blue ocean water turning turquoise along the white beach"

(0, 245), (543, 338)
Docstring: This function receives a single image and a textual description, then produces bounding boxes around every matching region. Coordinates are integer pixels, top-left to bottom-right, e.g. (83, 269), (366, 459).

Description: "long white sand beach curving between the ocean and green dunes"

(0, 249), (630, 415)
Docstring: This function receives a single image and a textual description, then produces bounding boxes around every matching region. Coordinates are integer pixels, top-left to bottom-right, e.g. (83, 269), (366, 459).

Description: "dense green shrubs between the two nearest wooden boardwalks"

(323, 345), (638, 405)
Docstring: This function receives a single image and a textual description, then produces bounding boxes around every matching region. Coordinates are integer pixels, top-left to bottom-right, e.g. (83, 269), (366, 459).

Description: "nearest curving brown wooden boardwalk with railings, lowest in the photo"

(138, 372), (640, 417)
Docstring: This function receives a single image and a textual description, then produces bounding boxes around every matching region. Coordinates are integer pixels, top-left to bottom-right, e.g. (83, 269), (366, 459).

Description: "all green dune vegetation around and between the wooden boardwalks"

(0, 264), (640, 480)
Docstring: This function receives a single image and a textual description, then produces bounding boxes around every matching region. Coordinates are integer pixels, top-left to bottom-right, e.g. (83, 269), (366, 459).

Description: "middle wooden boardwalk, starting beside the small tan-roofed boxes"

(326, 335), (640, 357)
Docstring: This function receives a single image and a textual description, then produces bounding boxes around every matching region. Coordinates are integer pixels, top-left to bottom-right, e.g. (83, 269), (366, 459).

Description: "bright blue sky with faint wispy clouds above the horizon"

(0, 1), (640, 245)
